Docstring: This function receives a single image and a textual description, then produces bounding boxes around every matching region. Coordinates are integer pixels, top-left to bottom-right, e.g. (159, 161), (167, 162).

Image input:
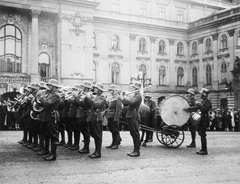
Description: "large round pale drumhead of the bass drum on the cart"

(160, 95), (190, 126)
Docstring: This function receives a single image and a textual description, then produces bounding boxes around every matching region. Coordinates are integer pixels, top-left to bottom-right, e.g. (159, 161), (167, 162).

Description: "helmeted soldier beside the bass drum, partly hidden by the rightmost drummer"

(187, 88), (197, 148)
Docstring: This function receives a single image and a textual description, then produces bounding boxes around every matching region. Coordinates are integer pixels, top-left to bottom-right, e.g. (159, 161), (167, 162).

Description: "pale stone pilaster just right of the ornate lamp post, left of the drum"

(149, 37), (157, 85)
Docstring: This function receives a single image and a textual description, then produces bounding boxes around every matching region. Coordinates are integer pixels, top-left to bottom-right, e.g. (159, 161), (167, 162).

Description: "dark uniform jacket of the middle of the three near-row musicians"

(84, 95), (107, 122)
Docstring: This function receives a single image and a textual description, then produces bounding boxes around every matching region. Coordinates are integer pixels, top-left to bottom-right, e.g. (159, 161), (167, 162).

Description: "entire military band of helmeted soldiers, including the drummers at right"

(1, 79), (216, 161)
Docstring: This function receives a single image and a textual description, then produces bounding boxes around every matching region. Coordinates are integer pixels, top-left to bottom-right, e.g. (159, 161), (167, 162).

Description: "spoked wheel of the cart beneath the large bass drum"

(162, 125), (185, 148)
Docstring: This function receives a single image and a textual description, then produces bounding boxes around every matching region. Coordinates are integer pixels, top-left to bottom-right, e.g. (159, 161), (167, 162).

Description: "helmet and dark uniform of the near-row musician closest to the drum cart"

(122, 81), (142, 157)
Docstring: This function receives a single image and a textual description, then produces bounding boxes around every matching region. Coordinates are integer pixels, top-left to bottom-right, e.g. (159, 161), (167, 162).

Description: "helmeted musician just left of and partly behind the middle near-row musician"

(75, 81), (92, 154)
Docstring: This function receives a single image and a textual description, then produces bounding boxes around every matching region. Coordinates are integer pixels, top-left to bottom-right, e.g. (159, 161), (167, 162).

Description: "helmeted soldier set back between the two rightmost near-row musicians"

(106, 84), (122, 149)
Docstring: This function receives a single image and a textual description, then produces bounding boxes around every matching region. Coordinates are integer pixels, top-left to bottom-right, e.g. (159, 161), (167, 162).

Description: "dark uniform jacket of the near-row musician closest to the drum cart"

(122, 93), (142, 118)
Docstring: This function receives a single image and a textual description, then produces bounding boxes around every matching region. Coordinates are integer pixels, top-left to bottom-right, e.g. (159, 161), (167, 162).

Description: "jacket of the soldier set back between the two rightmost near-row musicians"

(106, 95), (122, 121)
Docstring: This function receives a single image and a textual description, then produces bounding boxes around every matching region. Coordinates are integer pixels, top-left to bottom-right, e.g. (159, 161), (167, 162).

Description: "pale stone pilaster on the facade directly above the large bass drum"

(168, 39), (177, 90)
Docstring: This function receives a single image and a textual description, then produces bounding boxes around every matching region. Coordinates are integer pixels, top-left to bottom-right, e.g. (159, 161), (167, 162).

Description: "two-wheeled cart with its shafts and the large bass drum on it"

(140, 95), (190, 148)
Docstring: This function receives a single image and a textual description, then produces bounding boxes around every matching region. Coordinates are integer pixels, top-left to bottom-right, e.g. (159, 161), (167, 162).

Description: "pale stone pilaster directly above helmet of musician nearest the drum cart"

(129, 34), (138, 80)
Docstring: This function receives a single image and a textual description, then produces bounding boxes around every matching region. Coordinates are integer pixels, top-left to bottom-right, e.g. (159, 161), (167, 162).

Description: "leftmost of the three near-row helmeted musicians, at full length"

(39, 79), (61, 161)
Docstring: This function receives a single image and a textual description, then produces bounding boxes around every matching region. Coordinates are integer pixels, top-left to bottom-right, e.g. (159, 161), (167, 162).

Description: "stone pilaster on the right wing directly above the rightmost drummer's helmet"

(198, 38), (205, 89)
